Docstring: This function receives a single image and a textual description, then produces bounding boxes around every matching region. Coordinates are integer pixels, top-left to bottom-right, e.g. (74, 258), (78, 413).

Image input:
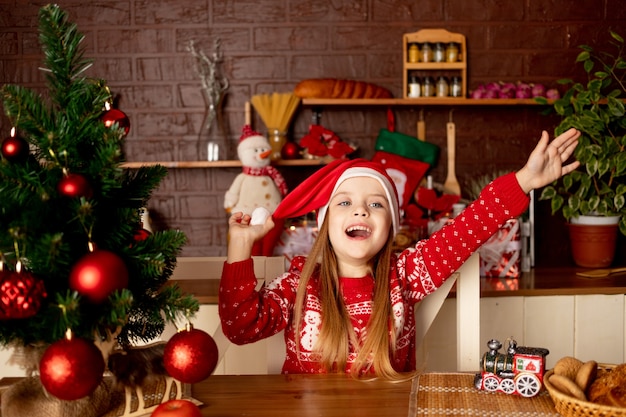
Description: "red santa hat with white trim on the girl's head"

(272, 159), (400, 234)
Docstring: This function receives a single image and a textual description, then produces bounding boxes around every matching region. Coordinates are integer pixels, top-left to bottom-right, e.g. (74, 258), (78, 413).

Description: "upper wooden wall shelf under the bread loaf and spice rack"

(302, 97), (554, 106)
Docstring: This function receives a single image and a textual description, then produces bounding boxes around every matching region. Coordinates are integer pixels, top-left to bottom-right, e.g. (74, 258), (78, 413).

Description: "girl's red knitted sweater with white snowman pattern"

(219, 173), (529, 373)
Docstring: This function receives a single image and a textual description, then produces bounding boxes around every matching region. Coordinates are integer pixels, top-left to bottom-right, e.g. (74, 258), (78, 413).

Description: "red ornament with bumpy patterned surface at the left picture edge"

(0, 270), (46, 320)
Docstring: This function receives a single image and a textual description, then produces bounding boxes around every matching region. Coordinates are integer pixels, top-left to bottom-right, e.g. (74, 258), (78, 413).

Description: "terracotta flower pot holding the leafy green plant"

(568, 219), (618, 268)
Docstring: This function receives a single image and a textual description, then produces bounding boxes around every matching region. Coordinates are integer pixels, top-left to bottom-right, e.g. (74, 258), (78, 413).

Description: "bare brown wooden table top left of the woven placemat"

(191, 374), (411, 417)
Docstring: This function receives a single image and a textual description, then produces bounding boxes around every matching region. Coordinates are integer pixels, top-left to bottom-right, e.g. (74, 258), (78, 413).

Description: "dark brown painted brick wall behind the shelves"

(0, 0), (626, 263)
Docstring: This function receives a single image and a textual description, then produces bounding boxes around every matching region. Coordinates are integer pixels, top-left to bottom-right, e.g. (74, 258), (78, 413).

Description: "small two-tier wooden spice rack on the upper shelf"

(402, 29), (467, 101)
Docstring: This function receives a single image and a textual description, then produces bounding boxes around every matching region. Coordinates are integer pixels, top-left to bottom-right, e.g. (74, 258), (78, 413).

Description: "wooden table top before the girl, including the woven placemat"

(0, 373), (559, 417)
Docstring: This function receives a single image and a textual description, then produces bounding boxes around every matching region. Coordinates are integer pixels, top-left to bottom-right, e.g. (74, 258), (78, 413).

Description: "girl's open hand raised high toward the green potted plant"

(516, 128), (580, 193)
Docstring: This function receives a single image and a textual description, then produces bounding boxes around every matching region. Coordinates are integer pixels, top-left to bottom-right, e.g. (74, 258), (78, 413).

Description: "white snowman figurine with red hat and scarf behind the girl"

(224, 125), (287, 256)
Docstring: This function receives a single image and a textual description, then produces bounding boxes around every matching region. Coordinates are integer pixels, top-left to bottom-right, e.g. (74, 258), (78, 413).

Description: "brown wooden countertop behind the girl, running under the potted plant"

(175, 267), (626, 304)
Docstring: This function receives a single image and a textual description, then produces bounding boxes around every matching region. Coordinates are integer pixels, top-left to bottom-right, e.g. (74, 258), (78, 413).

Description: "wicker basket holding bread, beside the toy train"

(543, 364), (626, 417)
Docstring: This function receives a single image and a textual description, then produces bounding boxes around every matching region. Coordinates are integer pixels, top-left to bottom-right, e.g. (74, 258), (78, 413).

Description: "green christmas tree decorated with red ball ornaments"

(0, 1), (198, 362)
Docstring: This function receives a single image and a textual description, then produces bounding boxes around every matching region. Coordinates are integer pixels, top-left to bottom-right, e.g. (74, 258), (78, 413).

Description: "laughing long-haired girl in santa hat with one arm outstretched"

(219, 129), (580, 379)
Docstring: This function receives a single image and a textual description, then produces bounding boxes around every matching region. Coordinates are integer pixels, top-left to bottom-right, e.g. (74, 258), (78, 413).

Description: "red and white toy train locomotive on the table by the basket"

(474, 339), (550, 397)
